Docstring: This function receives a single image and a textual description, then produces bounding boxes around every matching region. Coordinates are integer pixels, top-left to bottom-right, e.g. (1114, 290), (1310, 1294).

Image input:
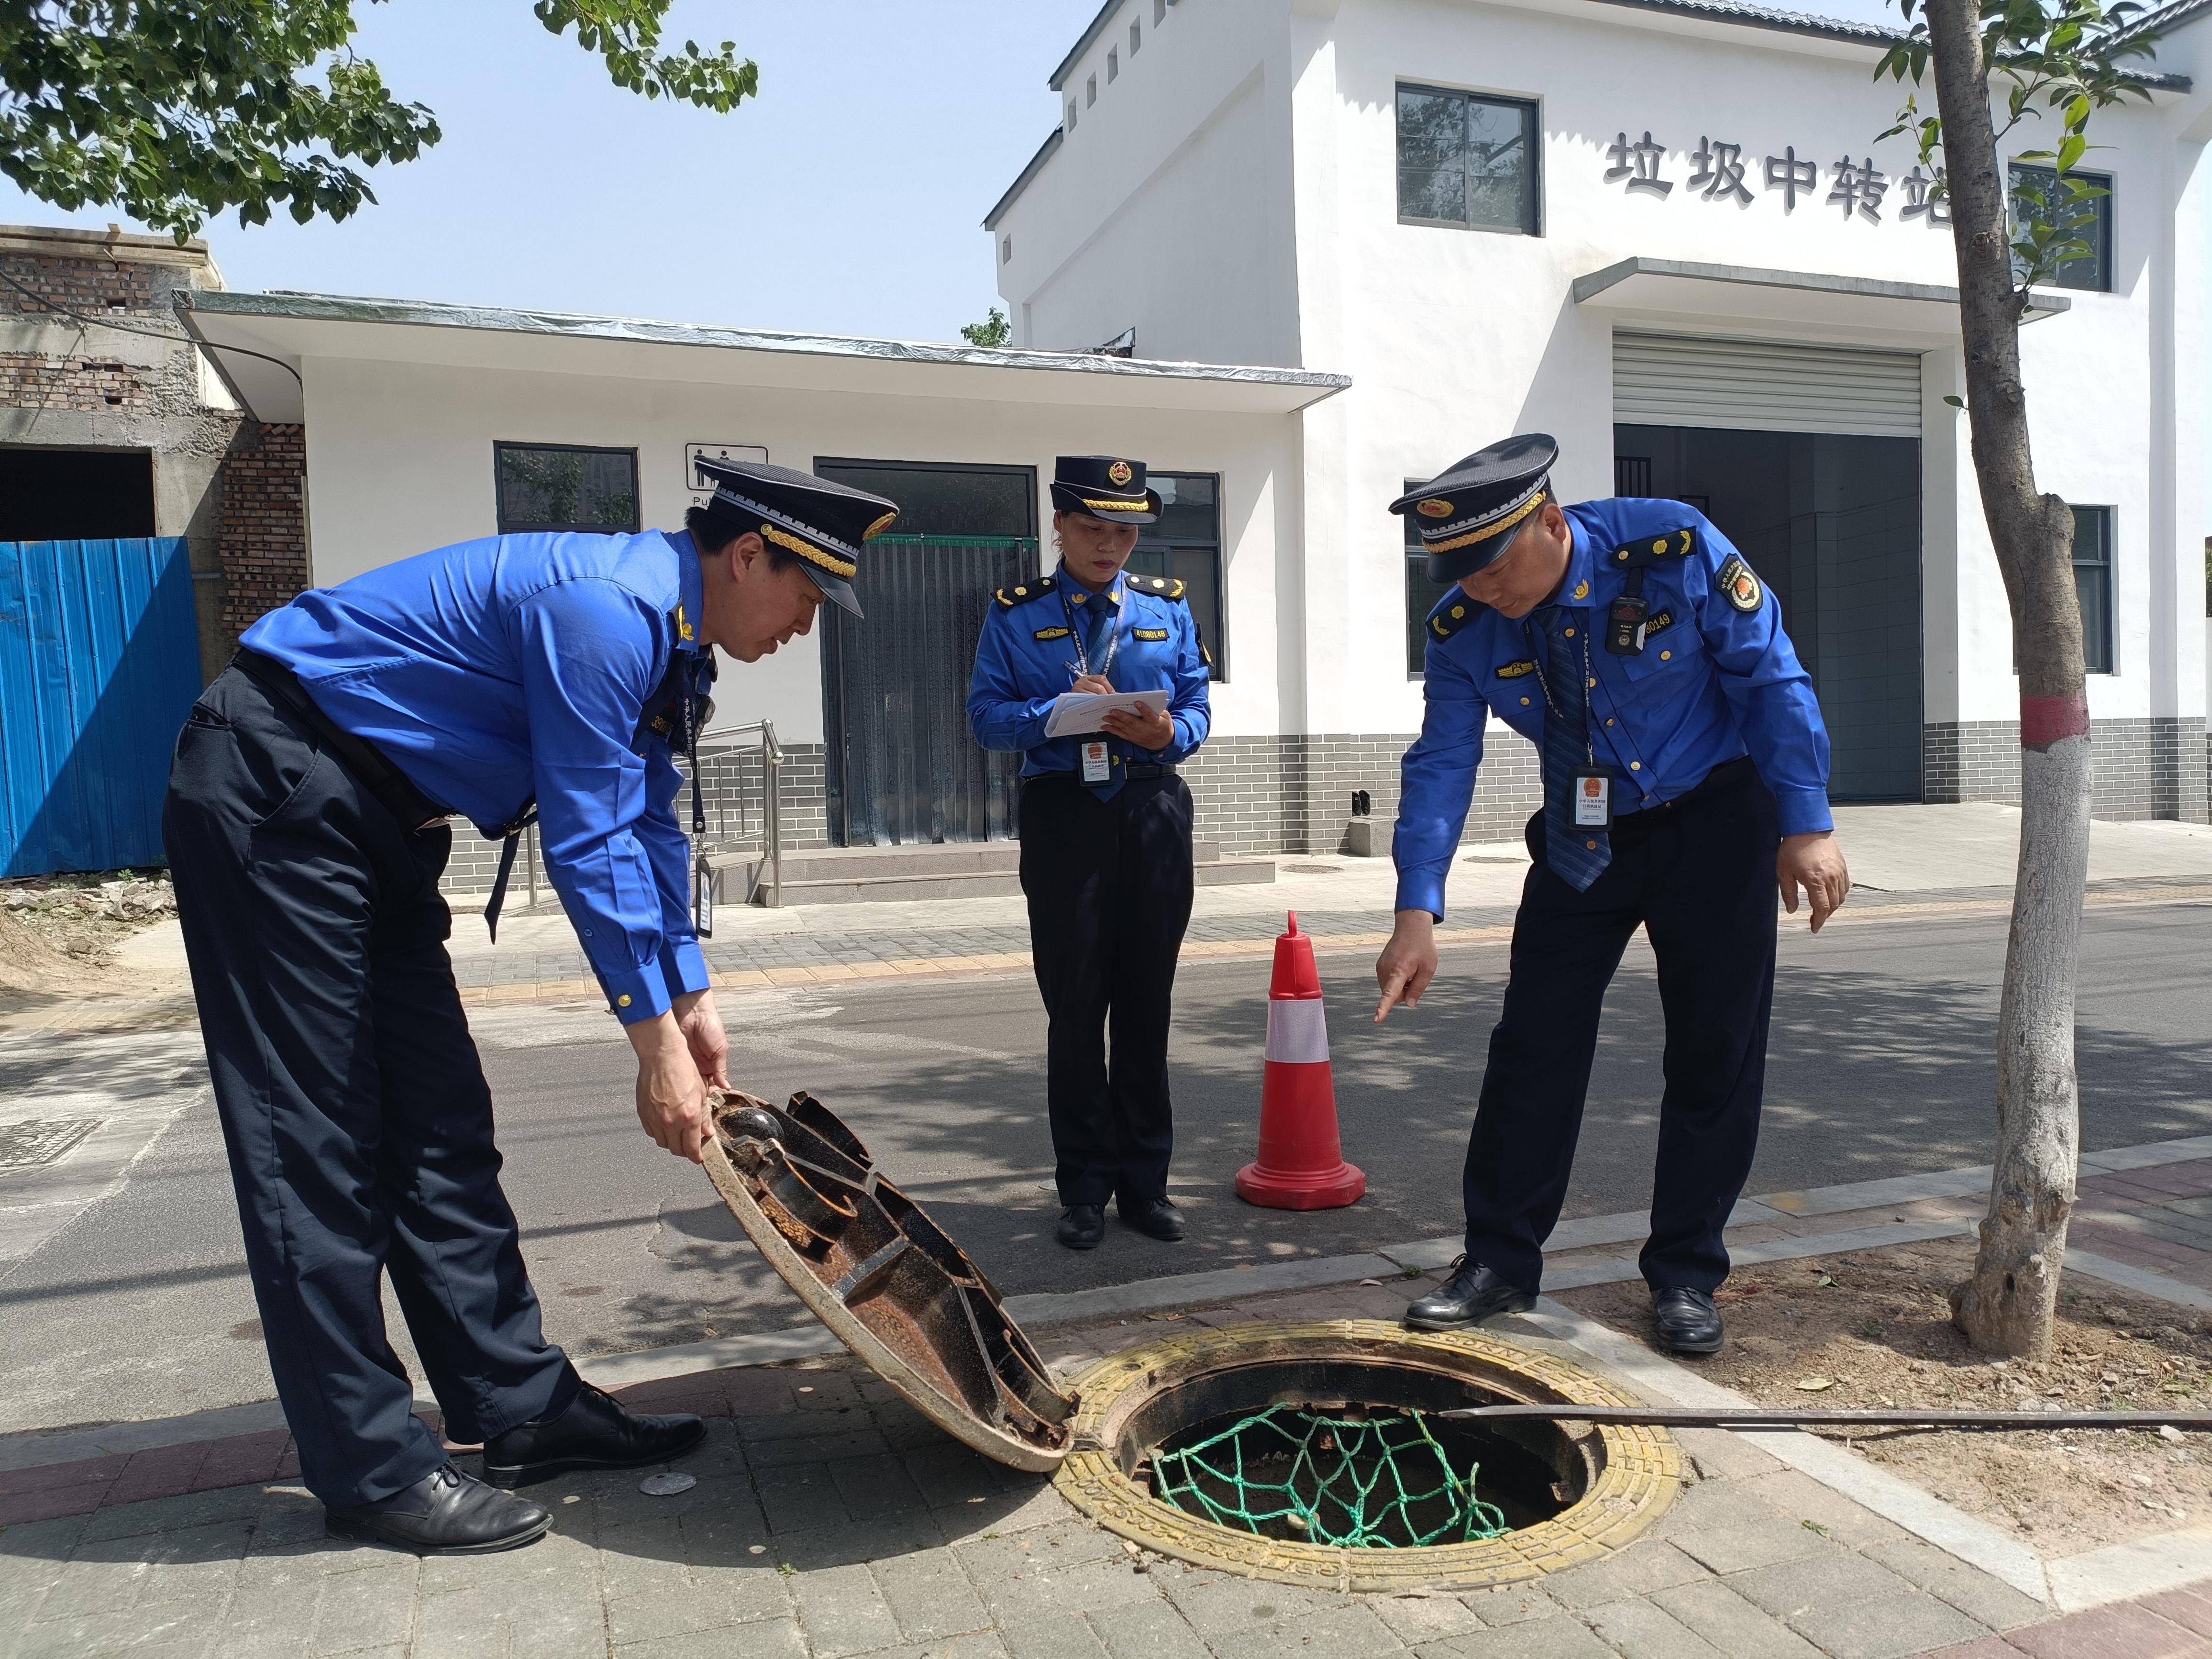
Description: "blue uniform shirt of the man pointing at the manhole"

(1391, 500), (1834, 918)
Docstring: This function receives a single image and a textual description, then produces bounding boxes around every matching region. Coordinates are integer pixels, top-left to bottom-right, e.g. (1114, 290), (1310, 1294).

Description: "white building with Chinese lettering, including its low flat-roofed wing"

(184, 0), (2212, 898)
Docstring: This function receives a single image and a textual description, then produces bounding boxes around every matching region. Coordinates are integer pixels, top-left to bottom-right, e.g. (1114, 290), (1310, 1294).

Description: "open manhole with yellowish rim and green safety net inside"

(1057, 1321), (1681, 1591)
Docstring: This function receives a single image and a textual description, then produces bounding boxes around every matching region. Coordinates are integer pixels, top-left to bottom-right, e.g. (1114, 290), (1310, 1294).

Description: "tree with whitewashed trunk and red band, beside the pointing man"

(1876, 0), (2155, 1358)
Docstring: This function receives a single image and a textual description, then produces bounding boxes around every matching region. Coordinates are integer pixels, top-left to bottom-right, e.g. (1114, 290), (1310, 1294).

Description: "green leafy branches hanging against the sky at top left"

(0, 0), (759, 241)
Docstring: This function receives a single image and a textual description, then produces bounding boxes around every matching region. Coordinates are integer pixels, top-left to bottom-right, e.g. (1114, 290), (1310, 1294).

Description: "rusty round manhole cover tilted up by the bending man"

(706, 1093), (1077, 1471)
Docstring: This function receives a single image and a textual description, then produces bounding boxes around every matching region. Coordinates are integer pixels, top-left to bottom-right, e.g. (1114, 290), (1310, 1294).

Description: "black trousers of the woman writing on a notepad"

(1022, 774), (1192, 1208)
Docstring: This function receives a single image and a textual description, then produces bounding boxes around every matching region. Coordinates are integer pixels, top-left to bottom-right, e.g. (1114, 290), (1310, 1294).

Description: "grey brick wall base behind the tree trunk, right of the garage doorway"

(1920, 715), (2212, 823)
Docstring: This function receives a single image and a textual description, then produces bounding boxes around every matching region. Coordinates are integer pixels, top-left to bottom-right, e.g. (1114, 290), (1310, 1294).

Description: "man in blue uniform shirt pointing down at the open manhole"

(1376, 433), (1851, 1354)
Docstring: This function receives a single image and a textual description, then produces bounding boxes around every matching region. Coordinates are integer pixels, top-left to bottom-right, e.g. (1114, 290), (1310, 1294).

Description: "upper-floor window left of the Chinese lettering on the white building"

(1398, 84), (1542, 237)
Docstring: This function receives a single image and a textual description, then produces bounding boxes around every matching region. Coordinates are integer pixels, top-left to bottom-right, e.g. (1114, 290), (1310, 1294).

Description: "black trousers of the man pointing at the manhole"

(1464, 763), (1781, 1292)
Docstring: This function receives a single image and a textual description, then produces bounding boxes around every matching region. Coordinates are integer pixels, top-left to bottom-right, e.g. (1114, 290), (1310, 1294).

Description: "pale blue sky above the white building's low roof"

(0, 0), (1898, 341)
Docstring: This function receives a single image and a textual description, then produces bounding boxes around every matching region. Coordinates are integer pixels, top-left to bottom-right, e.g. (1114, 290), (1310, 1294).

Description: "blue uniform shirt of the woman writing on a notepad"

(969, 573), (1212, 790)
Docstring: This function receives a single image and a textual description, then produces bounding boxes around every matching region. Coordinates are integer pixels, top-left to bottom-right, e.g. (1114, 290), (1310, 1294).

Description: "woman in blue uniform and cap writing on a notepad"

(969, 456), (1212, 1250)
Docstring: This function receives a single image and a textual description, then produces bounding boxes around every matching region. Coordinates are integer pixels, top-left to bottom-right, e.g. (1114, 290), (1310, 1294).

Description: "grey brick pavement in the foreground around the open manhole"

(0, 1283), (2124, 1659)
